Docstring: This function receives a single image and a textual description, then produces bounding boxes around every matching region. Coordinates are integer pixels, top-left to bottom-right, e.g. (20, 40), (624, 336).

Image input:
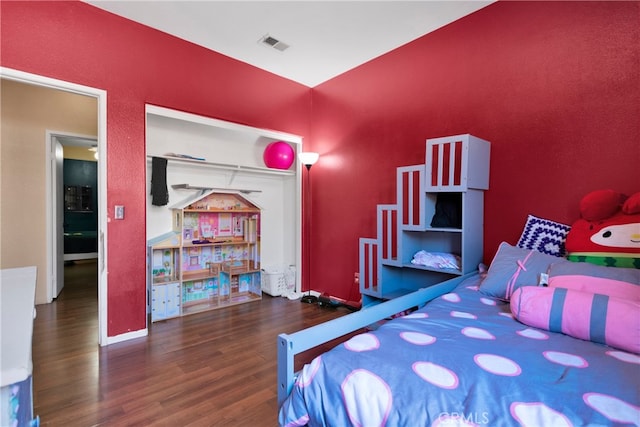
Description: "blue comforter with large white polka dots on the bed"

(279, 278), (640, 427)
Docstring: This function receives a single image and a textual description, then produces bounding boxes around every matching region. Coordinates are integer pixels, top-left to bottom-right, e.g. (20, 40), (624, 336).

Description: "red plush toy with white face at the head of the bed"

(565, 190), (640, 268)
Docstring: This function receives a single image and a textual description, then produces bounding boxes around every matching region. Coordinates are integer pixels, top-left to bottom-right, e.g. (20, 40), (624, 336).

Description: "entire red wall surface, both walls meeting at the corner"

(0, 1), (640, 320)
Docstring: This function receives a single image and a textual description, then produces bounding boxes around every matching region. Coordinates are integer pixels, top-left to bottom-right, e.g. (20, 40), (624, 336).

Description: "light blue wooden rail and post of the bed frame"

(278, 272), (477, 407)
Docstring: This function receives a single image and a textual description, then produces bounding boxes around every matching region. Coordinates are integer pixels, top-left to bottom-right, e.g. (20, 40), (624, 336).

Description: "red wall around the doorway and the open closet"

(0, 1), (311, 336)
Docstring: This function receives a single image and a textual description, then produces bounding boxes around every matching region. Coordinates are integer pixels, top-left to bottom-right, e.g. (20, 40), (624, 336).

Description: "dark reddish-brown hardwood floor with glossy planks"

(33, 262), (348, 427)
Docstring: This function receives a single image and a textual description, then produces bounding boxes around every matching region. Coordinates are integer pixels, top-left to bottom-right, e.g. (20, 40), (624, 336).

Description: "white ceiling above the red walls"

(85, 0), (493, 87)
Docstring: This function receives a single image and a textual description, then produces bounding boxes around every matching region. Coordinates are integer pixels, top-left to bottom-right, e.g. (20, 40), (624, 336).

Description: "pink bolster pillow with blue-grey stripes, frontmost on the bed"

(511, 286), (640, 353)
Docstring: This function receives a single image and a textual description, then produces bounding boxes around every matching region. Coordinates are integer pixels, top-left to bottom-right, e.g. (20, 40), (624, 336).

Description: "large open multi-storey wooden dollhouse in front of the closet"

(148, 190), (262, 322)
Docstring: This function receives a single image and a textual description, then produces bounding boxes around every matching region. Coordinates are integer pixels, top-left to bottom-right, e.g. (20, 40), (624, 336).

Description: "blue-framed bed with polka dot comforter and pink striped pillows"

(278, 243), (640, 426)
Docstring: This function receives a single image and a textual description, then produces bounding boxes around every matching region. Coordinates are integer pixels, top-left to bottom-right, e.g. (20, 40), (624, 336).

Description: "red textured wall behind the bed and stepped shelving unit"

(311, 1), (640, 298)
